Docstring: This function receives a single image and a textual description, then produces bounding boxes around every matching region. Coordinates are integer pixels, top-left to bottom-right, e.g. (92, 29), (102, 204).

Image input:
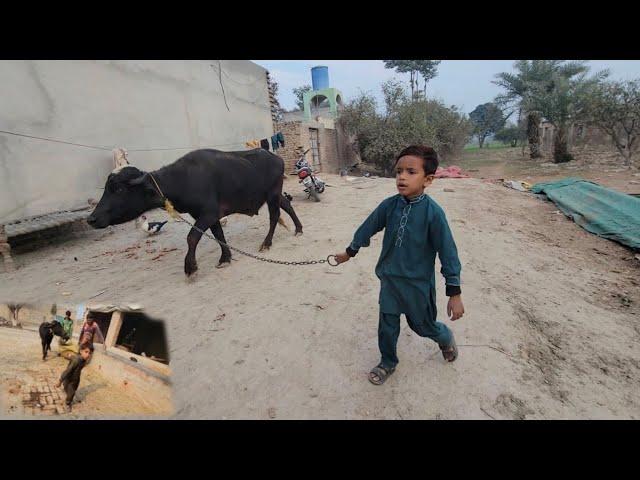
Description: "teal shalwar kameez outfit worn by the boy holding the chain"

(347, 194), (461, 369)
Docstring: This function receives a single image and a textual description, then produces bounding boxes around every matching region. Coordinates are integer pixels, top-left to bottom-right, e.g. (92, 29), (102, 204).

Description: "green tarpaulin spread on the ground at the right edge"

(531, 177), (640, 249)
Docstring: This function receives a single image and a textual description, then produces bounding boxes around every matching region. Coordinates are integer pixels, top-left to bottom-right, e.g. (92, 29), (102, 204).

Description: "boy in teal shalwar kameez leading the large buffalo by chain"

(336, 145), (464, 385)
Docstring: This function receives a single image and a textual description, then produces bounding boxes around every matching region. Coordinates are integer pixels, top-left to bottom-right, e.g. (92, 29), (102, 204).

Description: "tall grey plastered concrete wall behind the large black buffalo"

(0, 60), (273, 223)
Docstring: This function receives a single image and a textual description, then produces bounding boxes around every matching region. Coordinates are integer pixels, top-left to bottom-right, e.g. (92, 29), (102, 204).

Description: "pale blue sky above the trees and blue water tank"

(252, 60), (640, 113)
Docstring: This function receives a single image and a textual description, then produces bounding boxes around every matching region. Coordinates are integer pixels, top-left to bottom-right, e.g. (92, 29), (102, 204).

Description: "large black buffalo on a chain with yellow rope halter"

(87, 148), (302, 276)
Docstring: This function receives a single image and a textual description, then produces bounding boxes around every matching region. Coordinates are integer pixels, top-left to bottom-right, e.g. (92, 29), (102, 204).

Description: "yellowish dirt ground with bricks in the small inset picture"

(0, 327), (170, 419)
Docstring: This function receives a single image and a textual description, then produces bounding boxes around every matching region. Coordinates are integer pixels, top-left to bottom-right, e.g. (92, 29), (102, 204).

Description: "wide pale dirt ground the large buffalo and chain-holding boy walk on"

(0, 156), (640, 419)
